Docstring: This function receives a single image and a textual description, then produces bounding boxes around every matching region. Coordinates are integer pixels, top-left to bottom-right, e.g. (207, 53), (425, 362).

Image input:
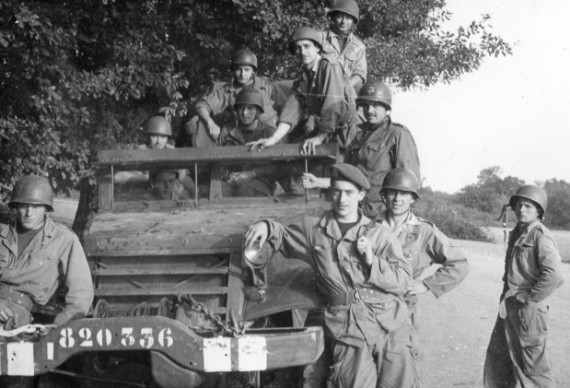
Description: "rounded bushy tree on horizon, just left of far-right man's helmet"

(457, 166), (524, 214)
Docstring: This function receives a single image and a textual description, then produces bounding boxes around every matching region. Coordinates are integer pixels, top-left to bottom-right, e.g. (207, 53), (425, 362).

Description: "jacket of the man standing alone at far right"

(501, 220), (564, 303)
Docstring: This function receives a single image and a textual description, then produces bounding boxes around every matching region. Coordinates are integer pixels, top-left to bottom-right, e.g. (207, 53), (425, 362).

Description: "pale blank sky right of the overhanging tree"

(392, 0), (570, 193)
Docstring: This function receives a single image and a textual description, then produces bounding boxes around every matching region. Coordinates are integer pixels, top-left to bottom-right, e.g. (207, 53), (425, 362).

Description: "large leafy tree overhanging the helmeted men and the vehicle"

(0, 0), (510, 199)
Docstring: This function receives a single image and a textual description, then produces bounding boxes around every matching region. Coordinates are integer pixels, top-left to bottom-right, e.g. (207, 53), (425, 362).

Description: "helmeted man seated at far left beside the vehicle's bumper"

(0, 175), (93, 327)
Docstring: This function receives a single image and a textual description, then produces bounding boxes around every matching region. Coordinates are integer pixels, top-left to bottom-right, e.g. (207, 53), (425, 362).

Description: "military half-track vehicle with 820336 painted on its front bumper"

(0, 144), (338, 387)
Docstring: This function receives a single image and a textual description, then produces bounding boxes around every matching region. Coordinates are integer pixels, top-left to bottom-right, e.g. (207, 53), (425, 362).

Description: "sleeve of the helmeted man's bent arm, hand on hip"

(420, 228), (469, 298)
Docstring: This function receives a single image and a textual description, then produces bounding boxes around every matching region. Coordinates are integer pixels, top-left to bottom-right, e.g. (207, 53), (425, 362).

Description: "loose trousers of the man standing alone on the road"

(483, 298), (555, 388)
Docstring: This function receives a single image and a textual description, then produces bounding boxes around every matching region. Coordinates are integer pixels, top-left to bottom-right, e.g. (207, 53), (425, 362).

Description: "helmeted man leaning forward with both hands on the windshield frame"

(248, 27), (356, 154)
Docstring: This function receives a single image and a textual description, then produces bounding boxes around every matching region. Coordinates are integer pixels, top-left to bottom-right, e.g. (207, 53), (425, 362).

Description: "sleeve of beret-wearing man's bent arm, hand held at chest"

(366, 230), (412, 295)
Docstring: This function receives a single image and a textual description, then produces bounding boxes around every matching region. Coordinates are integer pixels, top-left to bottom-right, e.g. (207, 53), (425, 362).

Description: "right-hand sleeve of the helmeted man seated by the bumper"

(54, 235), (93, 325)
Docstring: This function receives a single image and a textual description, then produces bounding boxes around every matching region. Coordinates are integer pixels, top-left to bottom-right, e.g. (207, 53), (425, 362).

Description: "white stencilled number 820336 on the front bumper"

(59, 327), (174, 349)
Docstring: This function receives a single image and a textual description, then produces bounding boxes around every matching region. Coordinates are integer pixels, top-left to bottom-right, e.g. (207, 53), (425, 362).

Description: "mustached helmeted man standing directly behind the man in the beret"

(303, 81), (421, 218)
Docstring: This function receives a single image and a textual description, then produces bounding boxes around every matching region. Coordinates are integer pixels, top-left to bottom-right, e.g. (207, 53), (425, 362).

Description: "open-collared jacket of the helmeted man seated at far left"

(0, 218), (93, 324)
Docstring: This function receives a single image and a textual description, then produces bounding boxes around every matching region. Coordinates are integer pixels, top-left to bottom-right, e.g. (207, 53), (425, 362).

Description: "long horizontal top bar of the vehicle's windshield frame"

(95, 143), (339, 169)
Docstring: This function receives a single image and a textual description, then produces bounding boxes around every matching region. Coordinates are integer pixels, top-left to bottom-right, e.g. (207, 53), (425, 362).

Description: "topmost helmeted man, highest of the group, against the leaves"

(321, 0), (367, 93)
